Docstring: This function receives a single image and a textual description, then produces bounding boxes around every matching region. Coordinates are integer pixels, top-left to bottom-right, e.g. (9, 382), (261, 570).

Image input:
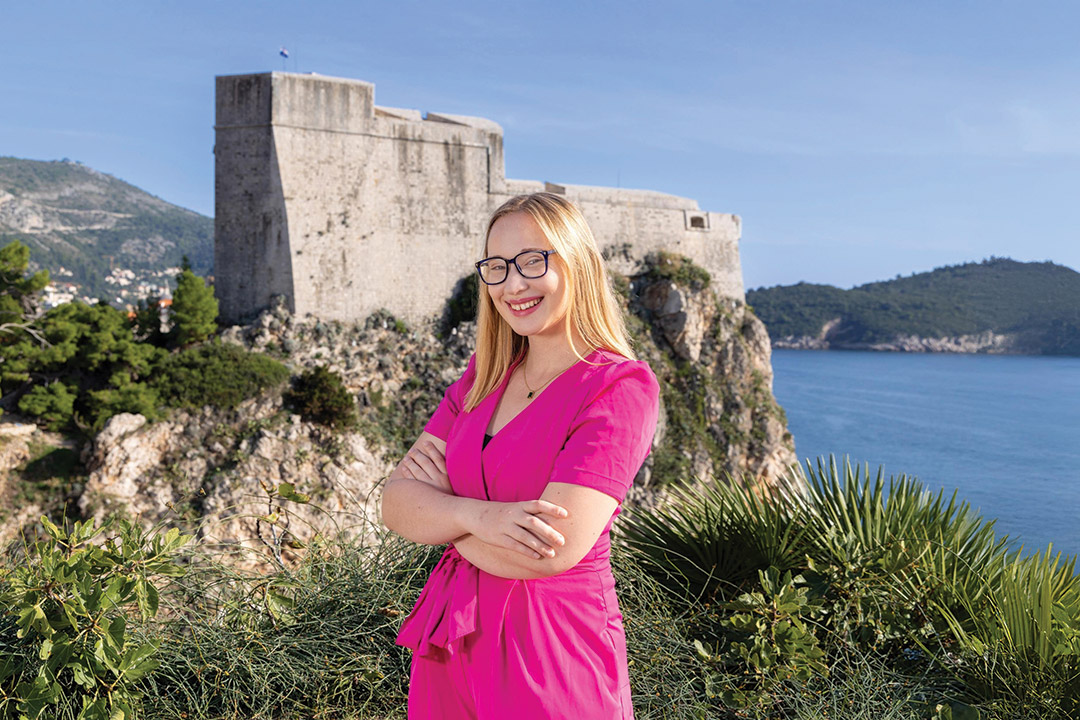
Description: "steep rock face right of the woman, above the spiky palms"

(629, 264), (797, 496)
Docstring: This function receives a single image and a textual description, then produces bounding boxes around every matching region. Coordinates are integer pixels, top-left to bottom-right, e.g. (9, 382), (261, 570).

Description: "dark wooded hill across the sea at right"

(746, 258), (1080, 355)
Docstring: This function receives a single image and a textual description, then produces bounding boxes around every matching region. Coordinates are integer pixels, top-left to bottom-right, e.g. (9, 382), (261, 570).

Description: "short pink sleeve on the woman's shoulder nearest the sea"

(550, 361), (660, 504)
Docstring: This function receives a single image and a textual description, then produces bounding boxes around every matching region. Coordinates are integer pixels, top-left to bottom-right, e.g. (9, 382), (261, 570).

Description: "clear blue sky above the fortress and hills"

(0, 0), (1080, 287)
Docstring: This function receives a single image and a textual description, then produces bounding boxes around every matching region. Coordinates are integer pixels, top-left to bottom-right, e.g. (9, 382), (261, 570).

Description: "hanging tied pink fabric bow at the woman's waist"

(397, 545), (480, 658)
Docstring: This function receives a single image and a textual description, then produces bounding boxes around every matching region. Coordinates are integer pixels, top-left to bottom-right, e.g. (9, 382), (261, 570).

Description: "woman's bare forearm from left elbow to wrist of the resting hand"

(382, 477), (484, 545)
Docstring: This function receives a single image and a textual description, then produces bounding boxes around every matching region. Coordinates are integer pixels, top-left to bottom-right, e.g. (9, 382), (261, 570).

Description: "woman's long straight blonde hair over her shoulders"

(464, 192), (634, 411)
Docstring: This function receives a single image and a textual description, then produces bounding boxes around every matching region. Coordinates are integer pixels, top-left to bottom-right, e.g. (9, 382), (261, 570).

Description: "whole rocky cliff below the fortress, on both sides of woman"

(0, 258), (796, 562)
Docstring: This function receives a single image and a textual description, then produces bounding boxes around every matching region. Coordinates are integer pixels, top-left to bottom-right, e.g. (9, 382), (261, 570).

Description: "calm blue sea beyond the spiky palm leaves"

(772, 350), (1080, 555)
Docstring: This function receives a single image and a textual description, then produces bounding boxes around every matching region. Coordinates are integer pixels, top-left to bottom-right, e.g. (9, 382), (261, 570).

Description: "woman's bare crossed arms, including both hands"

(382, 433), (618, 580)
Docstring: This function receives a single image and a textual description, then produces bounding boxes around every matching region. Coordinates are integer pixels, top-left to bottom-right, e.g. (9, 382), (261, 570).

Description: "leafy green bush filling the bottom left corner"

(0, 517), (190, 720)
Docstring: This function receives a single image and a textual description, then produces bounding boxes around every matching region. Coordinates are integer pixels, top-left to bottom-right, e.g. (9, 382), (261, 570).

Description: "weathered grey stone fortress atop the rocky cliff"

(214, 72), (744, 323)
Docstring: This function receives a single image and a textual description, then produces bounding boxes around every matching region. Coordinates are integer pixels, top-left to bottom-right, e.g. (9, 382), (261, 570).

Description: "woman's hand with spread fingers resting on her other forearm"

(460, 500), (567, 559)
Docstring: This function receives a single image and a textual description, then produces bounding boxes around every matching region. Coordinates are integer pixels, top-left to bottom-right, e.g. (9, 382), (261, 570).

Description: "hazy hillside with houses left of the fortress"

(0, 158), (214, 297)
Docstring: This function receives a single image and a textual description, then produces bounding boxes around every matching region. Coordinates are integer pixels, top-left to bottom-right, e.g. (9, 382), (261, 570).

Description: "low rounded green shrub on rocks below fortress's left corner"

(151, 342), (288, 409)
